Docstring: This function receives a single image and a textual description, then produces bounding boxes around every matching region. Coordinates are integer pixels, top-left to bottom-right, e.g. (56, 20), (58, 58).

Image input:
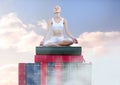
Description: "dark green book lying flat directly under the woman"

(36, 46), (82, 55)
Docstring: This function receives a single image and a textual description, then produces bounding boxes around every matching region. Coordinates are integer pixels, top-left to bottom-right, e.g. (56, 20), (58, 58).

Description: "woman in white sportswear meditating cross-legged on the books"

(40, 5), (78, 46)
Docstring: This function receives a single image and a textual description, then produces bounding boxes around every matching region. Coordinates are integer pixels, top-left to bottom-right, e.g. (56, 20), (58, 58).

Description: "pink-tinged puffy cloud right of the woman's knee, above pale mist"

(78, 32), (120, 57)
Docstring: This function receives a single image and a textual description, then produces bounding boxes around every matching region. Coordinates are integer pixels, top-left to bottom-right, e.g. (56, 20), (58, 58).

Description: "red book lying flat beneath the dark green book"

(35, 55), (84, 63)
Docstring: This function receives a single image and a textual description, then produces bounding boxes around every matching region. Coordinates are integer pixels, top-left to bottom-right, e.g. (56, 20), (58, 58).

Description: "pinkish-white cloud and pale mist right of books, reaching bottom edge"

(78, 32), (120, 85)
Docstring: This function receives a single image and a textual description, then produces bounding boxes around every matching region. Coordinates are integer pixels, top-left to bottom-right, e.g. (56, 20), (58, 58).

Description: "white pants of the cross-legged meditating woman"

(44, 36), (73, 46)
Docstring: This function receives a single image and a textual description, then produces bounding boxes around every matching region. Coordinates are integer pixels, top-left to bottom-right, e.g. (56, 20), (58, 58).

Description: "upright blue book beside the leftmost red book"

(26, 63), (40, 85)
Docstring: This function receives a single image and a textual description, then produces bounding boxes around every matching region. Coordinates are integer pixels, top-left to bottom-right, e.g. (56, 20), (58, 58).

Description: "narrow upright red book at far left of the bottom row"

(18, 63), (26, 85)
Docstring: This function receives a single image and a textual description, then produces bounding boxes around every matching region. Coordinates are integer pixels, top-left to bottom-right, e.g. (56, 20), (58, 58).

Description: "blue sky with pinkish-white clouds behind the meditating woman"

(0, 0), (120, 85)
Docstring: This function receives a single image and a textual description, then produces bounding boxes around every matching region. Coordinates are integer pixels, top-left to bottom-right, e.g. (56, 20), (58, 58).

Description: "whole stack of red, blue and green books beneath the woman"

(19, 47), (91, 85)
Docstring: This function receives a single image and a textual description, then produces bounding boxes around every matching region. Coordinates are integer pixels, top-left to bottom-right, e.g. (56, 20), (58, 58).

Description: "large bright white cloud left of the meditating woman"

(0, 13), (42, 52)
